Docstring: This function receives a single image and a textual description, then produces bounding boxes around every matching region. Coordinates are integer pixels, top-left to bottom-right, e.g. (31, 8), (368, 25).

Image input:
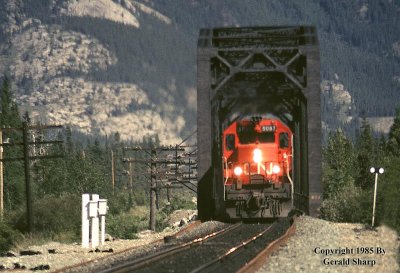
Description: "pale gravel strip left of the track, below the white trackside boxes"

(0, 221), (227, 273)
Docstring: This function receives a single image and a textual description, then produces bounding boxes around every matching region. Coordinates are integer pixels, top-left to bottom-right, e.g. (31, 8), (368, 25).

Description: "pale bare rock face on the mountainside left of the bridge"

(0, 0), (185, 144)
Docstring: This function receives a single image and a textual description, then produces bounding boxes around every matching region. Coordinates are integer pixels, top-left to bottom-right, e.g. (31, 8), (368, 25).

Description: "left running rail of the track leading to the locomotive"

(99, 223), (243, 273)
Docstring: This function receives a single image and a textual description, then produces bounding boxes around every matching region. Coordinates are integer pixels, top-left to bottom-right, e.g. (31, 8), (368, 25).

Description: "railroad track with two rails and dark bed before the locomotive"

(100, 218), (292, 273)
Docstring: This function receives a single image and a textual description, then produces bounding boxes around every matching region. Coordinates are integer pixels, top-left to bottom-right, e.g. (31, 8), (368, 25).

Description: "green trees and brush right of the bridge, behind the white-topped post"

(321, 111), (400, 231)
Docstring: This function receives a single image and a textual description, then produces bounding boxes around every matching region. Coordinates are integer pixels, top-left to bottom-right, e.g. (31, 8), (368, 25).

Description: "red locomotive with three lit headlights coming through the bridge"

(222, 117), (293, 219)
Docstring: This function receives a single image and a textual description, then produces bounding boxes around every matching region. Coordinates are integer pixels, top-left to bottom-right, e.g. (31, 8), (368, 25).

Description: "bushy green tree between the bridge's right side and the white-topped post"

(321, 126), (372, 223)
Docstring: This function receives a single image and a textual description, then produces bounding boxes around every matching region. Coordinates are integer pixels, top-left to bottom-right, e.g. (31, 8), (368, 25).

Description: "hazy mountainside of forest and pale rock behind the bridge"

(0, 0), (400, 143)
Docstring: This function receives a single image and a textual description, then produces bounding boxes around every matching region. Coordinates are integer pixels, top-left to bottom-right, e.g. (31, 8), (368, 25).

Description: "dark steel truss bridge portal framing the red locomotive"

(197, 26), (322, 218)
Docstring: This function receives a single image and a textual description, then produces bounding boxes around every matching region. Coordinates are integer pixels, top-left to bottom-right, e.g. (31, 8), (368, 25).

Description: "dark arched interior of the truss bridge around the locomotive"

(211, 71), (308, 215)
